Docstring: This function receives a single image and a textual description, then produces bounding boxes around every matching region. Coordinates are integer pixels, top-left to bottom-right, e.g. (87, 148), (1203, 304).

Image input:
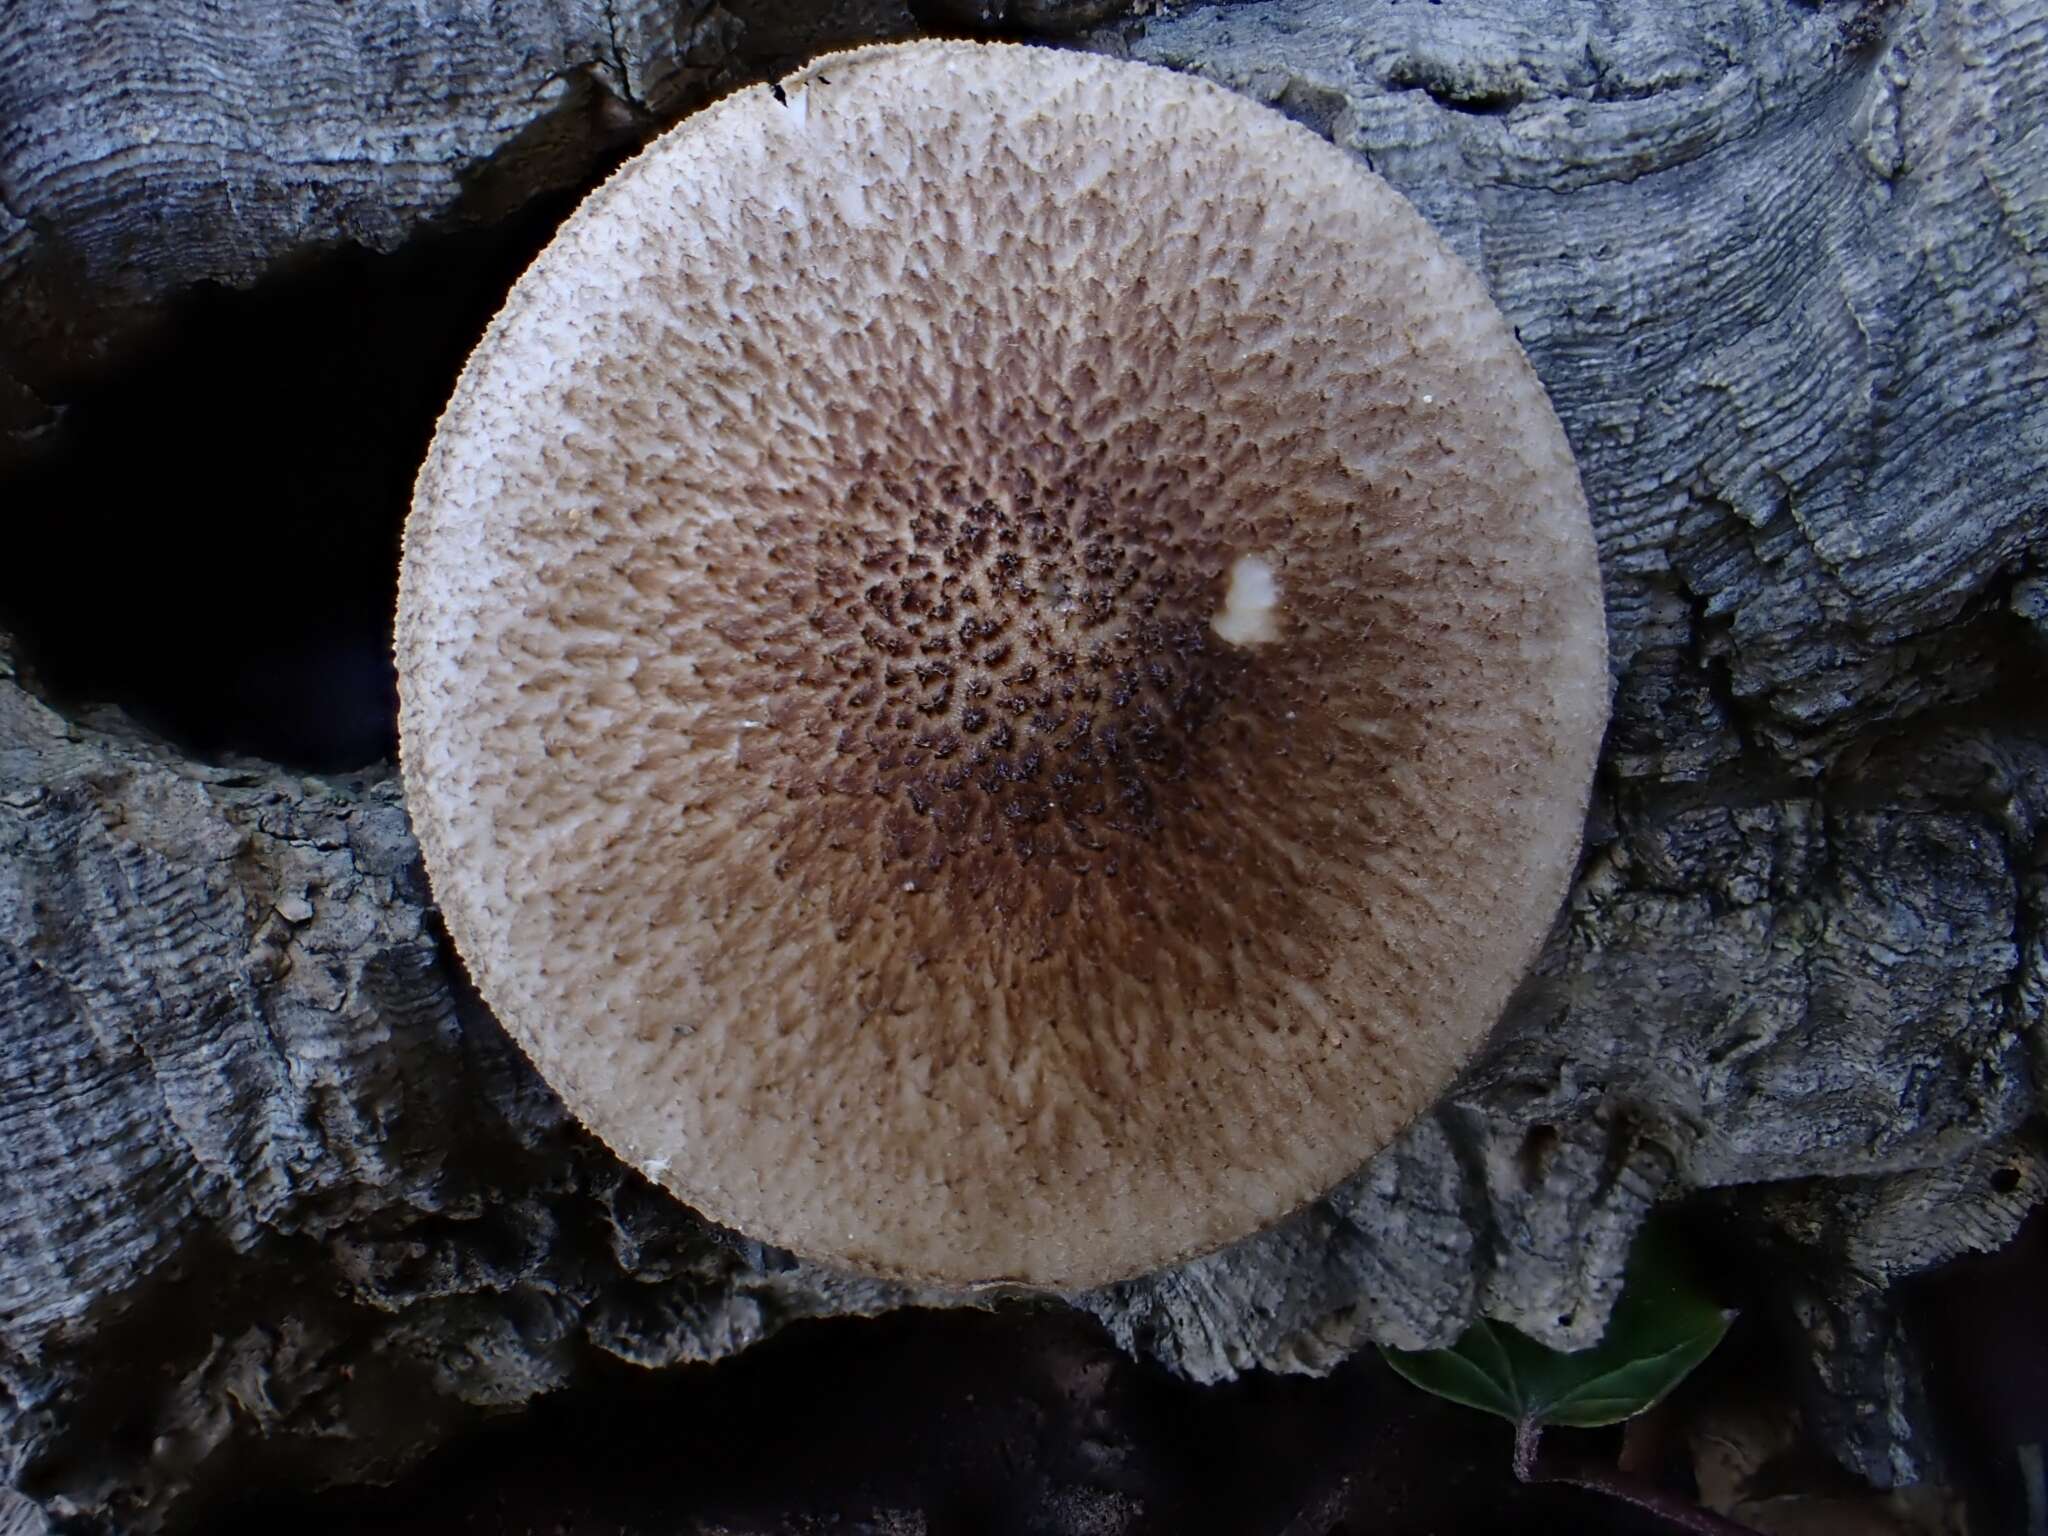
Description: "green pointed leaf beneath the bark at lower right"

(1380, 1223), (1735, 1430)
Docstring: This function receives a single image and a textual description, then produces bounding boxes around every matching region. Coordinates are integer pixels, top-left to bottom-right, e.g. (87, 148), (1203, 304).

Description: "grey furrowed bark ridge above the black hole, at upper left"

(0, 0), (911, 465)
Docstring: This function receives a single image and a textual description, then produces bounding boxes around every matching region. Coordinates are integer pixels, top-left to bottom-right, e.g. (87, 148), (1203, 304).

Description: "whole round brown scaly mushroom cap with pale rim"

(397, 43), (1608, 1286)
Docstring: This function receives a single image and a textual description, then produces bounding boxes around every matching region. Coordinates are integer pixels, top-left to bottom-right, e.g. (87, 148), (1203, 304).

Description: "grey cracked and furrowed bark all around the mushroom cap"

(0, 0), (2048, 1530)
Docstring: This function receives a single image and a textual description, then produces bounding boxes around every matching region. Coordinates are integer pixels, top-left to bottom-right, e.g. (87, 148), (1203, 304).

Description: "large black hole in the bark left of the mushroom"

(0, 193), (578, 772)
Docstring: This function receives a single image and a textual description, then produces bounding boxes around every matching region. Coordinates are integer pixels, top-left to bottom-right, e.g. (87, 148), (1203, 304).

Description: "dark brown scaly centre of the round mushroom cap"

(712, 444), (1257, 925)
